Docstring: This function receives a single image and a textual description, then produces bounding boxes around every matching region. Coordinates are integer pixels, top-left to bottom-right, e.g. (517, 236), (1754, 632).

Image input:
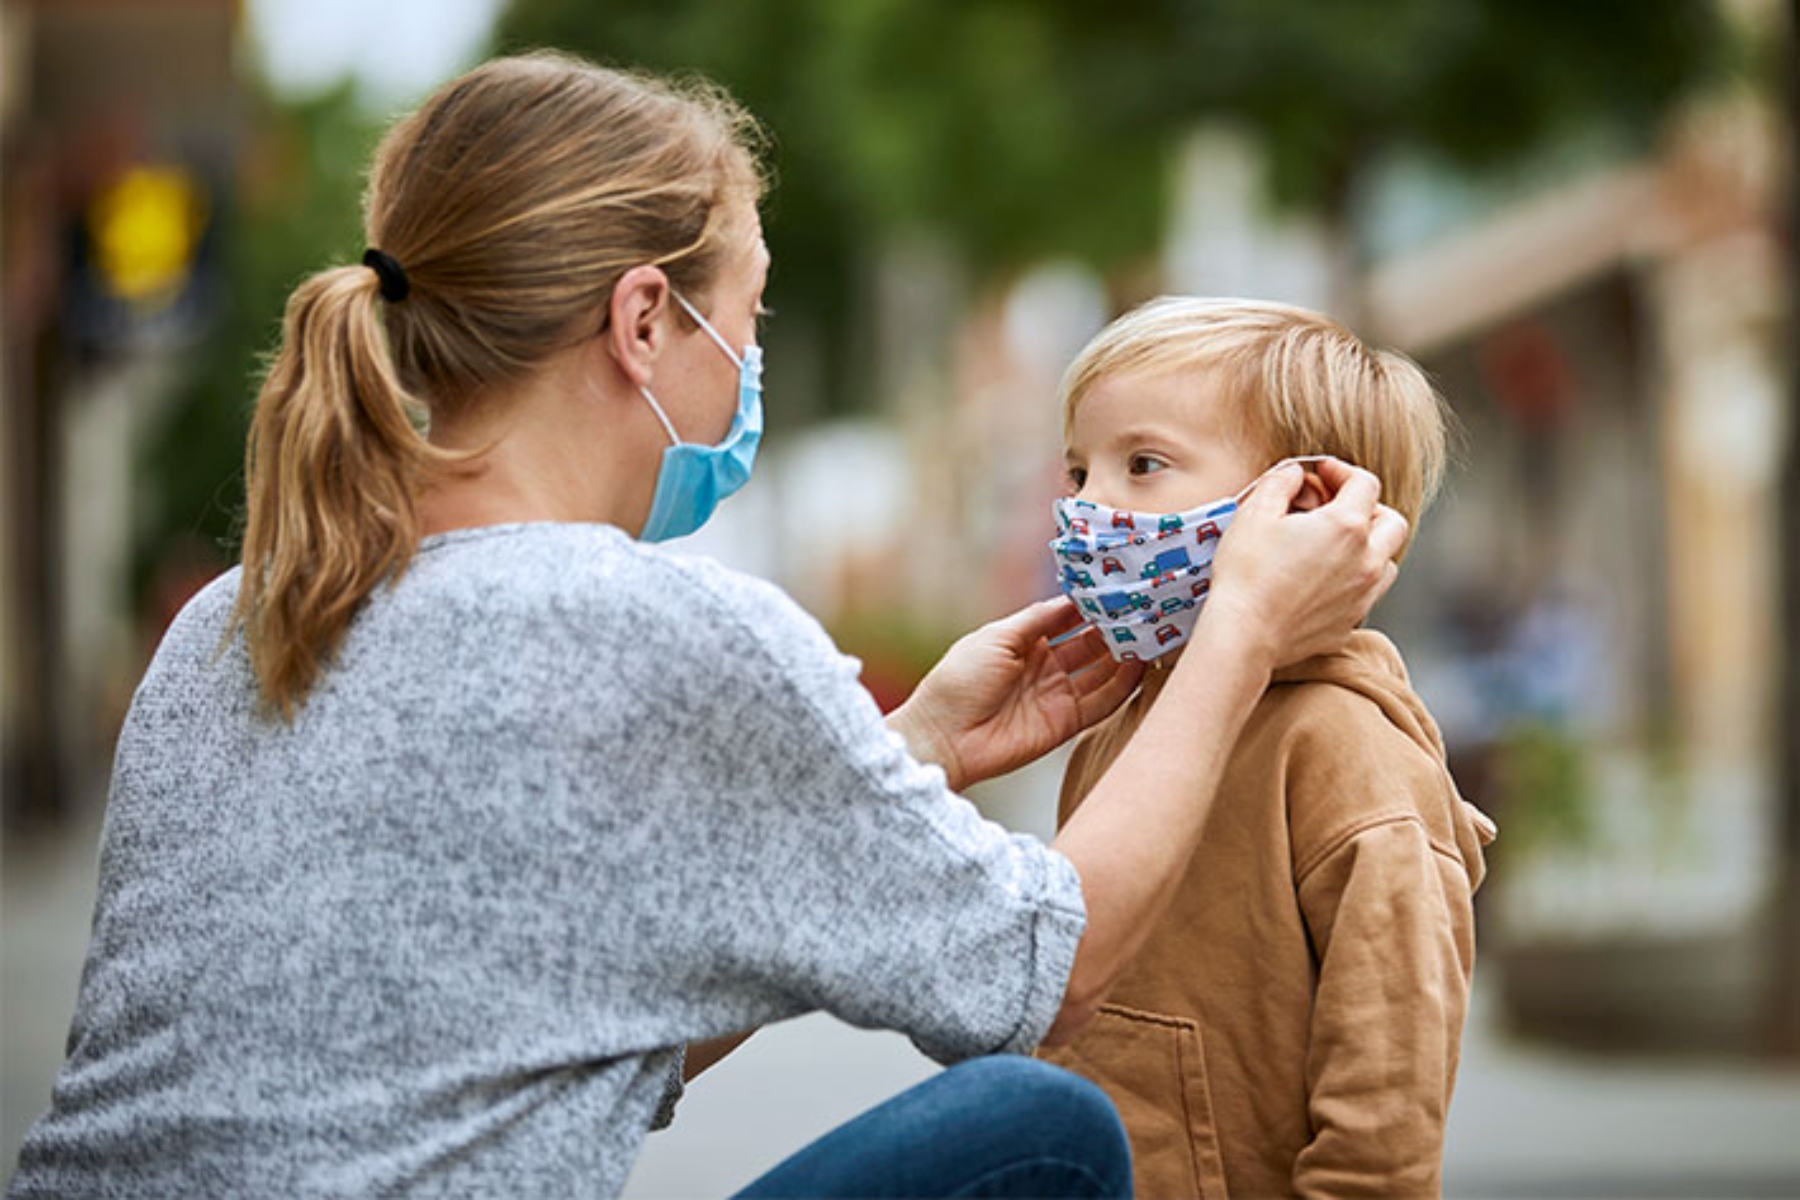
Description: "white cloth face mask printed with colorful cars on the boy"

(1049, 455), (1323, 662)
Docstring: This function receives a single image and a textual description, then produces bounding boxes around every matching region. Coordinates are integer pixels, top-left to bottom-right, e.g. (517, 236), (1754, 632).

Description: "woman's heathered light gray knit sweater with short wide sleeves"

(9, 525), (1084, 1198)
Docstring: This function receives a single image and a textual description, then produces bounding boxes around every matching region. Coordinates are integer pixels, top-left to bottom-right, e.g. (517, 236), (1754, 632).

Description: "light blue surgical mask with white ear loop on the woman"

(637, 293), (763, 542)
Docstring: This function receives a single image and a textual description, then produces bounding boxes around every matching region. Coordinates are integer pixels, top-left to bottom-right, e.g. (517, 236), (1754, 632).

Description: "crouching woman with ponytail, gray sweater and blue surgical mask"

(13, 56), (1402, 1196)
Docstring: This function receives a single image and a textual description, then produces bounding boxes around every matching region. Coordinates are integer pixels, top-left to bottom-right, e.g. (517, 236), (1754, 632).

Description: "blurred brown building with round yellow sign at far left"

(0, 0), (239, 820)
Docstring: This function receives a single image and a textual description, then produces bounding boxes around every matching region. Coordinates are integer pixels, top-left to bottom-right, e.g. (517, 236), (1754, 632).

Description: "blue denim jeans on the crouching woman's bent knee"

(738, 1054), (1130, 1200)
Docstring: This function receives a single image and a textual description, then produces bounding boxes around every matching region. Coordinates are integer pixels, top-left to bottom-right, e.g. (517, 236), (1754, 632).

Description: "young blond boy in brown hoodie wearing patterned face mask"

(1042, 299), (1494, 1200)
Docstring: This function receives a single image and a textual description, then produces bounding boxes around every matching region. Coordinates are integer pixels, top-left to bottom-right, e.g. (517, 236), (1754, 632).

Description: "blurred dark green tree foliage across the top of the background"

(499, 0), (1723, 354)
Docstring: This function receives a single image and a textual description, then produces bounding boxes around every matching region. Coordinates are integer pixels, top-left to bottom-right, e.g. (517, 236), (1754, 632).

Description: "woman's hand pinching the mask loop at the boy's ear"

(1201, 459), (1408, 671)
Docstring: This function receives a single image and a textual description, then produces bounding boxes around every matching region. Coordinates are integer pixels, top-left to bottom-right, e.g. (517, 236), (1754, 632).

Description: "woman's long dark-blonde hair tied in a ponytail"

(234, 52), (763, 718)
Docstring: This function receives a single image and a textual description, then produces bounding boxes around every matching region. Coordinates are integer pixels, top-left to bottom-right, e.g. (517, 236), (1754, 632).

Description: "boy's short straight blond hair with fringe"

(1062, 297), (1449, 543)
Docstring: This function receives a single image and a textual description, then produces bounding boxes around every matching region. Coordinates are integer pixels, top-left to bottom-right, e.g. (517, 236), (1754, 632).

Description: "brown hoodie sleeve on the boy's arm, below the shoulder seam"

(1294, 811), (1472, 1196)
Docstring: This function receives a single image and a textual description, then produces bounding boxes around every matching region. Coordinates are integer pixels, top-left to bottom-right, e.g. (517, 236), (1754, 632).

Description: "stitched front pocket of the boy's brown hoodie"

(1040, 1004), (1229, 1200)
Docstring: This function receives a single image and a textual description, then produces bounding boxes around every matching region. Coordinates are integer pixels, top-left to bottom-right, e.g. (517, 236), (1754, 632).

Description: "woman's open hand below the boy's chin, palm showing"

(887, 597), (1143, 790)
